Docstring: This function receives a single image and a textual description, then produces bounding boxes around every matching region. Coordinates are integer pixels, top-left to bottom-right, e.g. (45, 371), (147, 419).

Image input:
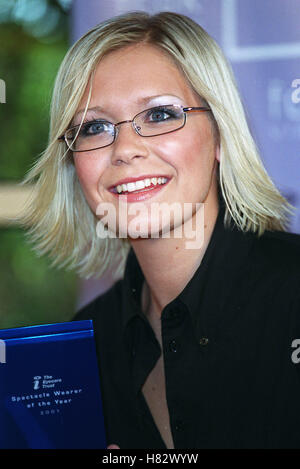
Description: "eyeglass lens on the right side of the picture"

(135, 105), (184, 137)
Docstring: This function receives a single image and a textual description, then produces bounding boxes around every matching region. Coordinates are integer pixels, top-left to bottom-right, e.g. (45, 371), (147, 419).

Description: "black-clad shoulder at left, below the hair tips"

(73, 279), (122, 324)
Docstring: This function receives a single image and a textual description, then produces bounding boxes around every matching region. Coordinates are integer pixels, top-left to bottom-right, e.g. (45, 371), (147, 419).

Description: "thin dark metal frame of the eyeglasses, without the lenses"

(57, 104), (211, 153)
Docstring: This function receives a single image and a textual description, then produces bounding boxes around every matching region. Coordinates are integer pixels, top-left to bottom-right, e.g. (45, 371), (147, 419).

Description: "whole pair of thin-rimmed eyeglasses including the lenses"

(58, 104), (211, 152)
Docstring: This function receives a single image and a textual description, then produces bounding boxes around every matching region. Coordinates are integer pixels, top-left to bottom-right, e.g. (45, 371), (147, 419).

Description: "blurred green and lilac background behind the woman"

(0, 0), (300, 328)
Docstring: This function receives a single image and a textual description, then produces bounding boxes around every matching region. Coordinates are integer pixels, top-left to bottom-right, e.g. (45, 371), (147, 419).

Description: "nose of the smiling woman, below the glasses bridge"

(111, 121), (148, 165)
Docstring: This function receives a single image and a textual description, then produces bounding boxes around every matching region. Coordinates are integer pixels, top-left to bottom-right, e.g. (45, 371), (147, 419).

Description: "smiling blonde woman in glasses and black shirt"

(24, 12), (300, 448)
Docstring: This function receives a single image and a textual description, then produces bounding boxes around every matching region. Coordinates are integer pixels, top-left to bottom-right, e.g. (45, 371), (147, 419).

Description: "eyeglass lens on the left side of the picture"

(66, 120), (114, 151)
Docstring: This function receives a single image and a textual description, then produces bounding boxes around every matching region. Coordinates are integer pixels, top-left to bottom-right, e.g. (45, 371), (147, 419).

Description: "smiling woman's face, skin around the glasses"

(74, 44), (218, 237)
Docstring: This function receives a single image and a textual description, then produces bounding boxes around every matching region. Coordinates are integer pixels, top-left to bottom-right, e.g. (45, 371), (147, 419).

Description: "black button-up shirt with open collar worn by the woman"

(75, 207), (300, 449)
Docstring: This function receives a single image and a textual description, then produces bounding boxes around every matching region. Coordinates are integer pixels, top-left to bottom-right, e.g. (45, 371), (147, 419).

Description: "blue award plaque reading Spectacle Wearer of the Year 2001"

(0, 320), (106, 449)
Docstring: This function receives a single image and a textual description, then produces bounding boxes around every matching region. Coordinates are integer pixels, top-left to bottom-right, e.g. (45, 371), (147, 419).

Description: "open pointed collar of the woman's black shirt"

(122, 201), (254, 327)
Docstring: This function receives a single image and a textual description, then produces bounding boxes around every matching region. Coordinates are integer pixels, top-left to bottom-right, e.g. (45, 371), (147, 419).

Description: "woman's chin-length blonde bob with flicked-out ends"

(20, 11), (293, 278)
